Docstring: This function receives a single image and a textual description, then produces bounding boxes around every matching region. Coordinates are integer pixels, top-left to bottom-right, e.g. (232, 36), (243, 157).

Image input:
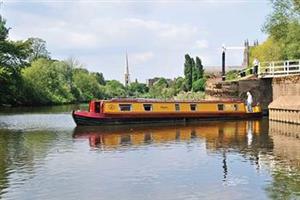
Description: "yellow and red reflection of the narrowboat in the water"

(73, 121), (261, 149)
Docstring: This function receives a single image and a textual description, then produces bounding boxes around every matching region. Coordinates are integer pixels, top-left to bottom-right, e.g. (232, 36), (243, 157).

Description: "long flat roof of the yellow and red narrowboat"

(94, 98), (243, 103)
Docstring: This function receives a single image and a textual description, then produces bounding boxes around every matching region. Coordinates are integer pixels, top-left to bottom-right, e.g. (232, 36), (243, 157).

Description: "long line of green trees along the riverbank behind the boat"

(0, 15), (206, 105)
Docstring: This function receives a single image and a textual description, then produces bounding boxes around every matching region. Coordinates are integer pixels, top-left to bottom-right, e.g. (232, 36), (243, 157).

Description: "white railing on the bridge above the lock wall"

(258, 60), (300, 78)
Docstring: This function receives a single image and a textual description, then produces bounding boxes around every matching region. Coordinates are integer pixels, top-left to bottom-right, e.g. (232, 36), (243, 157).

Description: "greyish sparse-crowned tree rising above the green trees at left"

(27, 38), (50, 62)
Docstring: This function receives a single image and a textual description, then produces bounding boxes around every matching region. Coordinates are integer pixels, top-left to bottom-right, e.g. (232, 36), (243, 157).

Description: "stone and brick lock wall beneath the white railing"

(205, 75), (300, 119)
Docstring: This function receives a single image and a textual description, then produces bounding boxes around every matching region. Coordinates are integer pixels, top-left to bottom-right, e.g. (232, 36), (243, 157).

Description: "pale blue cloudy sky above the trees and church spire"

(1, 0), (271, 82)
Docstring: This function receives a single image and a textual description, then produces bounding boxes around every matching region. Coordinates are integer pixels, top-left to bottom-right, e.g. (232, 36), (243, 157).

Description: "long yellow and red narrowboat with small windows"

(72, 98), (262, 126)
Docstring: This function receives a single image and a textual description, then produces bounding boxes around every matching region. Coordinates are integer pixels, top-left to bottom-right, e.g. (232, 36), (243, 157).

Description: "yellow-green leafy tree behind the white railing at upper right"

(250, 0), (300, 63)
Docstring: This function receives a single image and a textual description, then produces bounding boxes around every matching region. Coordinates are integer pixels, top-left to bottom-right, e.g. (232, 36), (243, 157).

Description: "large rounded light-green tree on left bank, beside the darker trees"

(22, 58), (75, 104)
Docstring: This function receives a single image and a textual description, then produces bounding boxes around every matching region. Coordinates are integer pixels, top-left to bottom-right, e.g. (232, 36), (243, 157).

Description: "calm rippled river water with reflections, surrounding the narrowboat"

(0, 106), (300, 200)
